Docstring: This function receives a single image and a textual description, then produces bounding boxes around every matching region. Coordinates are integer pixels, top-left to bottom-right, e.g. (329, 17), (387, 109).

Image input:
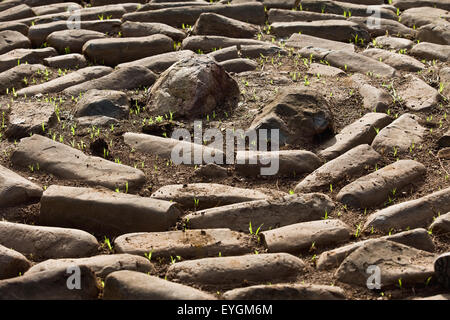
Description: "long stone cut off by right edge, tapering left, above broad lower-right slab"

(364, 188), (450, 231)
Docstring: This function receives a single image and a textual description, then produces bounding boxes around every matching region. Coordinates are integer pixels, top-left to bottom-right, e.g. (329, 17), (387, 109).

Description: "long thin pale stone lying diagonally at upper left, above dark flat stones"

(17, 64), (113, 96)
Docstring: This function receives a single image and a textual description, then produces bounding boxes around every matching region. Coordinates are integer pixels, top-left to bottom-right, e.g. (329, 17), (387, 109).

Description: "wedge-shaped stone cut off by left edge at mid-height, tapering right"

(0, 165), (42, 208)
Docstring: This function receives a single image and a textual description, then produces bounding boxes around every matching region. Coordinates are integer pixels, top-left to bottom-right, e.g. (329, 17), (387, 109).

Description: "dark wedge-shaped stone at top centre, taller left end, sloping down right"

(192, 12), (259, 38)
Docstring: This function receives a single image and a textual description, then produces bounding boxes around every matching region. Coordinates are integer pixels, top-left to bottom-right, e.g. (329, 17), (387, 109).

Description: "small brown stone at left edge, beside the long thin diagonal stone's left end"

(0, 64), (45, 93)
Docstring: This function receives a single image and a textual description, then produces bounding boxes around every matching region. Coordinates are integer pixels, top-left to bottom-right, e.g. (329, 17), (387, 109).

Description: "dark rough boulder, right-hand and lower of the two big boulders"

(249, 87), (333, 145)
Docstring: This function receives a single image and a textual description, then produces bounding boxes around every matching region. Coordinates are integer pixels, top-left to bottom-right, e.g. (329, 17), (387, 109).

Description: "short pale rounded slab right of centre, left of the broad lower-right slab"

(261, 219), (351, 253)
